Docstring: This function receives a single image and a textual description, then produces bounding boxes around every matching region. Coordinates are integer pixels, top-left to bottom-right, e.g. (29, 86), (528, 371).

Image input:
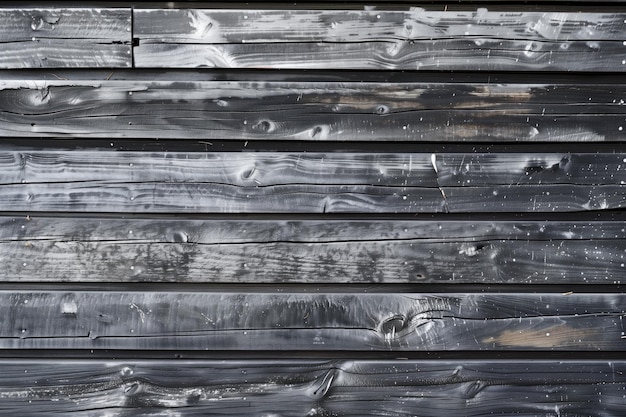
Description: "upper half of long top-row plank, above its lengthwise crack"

(133, 8), (626, 43)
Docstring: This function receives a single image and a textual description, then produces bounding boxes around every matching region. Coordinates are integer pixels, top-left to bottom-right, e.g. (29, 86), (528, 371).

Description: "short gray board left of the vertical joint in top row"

(0, 8), (132, 68)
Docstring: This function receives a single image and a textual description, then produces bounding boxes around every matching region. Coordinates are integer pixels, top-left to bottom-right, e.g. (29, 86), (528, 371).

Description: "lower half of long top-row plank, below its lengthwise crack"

(134, 39), (626, 72)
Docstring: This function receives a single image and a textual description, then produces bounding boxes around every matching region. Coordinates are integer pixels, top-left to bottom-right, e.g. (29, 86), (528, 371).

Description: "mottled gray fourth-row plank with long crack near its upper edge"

(0, 216), (626, 284)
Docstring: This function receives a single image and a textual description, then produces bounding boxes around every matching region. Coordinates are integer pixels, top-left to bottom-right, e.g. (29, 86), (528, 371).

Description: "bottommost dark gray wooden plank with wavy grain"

(0, 360), (626, 417)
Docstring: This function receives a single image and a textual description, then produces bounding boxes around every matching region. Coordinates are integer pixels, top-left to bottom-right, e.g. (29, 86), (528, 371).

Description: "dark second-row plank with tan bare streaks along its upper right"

(0, 78), (626, 142)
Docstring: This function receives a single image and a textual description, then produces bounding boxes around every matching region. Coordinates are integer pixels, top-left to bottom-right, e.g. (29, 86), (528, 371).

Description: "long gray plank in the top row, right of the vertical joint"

(133, 8), (626, 72)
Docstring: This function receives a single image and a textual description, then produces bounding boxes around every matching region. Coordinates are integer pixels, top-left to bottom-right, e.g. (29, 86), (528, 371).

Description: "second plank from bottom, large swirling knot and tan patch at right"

(0, 288), (626, 351)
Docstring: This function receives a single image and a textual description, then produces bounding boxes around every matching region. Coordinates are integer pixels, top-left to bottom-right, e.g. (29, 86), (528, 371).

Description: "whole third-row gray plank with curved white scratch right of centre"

(0, 147), (626, 213)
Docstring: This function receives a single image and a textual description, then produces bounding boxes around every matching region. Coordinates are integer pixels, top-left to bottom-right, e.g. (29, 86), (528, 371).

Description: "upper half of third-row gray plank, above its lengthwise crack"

(0, 150), (626, 187)
